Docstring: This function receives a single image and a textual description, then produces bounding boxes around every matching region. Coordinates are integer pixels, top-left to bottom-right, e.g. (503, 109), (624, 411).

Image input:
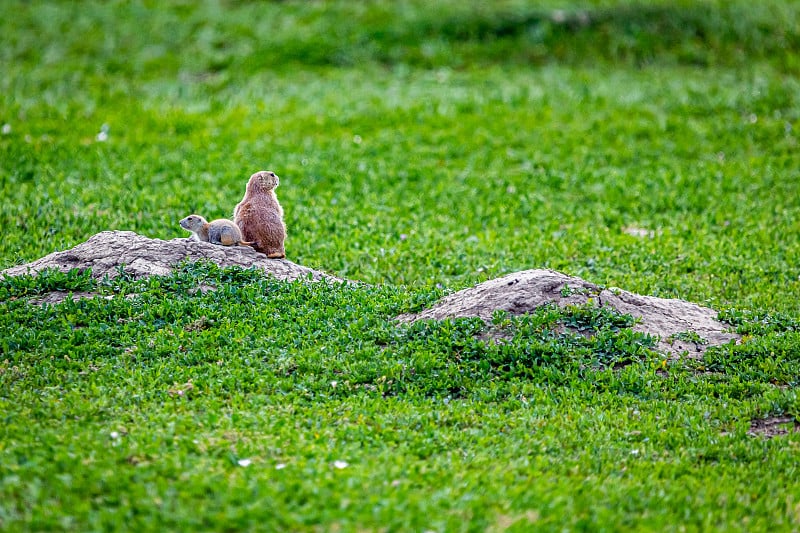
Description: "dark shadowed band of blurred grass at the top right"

(360, 2), (800, 69)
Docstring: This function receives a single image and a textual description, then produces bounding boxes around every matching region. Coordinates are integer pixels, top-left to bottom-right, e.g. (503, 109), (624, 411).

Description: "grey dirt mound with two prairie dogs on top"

(2, 231), (341, 281)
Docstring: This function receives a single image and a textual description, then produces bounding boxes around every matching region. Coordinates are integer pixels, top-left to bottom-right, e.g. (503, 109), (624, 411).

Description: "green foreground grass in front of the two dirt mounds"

(0, 266), (800, 531)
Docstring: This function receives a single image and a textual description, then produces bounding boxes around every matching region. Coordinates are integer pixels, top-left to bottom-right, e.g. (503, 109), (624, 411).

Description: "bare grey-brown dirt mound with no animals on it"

(397, 270), (741, 357)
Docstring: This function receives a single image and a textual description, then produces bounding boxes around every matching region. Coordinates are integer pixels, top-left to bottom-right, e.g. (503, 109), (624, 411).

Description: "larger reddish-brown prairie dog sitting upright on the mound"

(233, 170), (286, 259)
